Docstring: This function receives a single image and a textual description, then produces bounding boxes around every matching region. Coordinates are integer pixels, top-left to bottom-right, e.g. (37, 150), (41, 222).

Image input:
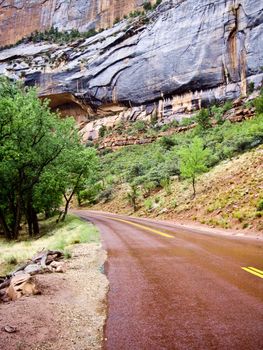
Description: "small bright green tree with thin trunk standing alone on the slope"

(179, 137), (210, 197)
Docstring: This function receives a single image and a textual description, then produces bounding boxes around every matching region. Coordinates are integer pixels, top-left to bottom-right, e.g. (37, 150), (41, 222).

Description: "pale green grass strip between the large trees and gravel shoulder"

(0, 215), (99, 276)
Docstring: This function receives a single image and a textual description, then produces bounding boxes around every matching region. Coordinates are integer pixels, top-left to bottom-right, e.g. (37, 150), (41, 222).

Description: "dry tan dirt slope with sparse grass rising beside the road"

(92, 146), (263, 232)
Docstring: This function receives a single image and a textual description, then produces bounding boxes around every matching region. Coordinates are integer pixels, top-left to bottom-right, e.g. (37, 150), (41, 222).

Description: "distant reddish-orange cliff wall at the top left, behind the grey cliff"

(0, 0), (146, 46)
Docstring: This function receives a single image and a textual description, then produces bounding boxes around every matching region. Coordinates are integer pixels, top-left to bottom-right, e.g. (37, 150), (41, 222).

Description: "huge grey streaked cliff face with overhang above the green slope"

(0, 0), (263, 137)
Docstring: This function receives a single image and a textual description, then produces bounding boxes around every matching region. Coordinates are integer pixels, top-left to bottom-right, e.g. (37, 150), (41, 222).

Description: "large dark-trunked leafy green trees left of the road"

(0, 79), (97, 239)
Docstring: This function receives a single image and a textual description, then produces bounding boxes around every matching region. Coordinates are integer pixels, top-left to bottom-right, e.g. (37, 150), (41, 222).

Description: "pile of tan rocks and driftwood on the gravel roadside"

(0, 250), (65, 301)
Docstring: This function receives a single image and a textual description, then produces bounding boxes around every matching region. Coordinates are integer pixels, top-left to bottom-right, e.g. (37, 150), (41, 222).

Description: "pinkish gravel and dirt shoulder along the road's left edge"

(0, 243), (108, 350)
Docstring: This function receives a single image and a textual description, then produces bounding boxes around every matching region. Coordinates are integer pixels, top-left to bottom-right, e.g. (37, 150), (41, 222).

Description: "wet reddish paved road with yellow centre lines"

(75, 211), (263, 350)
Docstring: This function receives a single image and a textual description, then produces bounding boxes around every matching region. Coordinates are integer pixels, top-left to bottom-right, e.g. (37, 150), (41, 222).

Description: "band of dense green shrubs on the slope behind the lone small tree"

(101, 108), (263, 204)
